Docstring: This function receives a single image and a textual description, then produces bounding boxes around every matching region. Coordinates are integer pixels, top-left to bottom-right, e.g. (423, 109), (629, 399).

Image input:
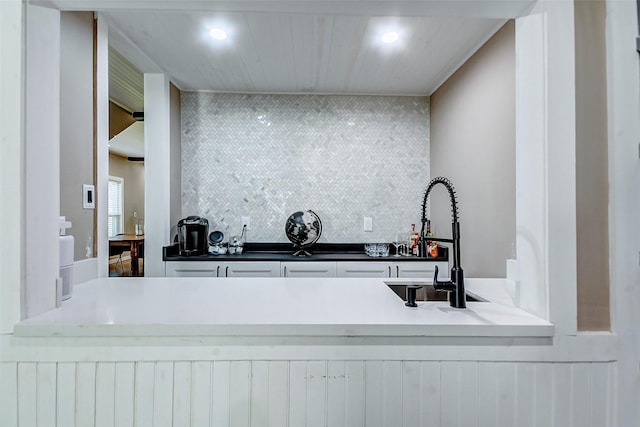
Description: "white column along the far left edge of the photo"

(0, 0), (24, 334)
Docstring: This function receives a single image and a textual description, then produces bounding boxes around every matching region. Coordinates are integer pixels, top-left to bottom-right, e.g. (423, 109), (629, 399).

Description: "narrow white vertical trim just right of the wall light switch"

(95, 14), (109, 277)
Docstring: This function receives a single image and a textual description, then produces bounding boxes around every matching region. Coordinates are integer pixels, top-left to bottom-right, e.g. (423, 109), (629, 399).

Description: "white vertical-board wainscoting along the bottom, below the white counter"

(0, 360), (615, 427)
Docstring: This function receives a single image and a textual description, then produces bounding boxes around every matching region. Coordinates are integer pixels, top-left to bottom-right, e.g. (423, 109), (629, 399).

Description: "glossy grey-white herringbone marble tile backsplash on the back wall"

(181, 92), (430, 243)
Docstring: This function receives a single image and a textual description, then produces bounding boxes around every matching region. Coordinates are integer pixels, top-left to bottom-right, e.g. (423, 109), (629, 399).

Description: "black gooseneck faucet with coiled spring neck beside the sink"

(418, 176), (467, 308)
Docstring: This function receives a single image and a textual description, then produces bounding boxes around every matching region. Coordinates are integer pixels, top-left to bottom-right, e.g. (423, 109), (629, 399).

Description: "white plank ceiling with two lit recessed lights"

(105, 10), (504, 95)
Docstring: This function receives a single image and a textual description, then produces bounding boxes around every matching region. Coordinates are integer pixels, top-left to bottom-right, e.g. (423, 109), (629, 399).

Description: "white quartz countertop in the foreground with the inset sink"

(14, 278), (554, 337)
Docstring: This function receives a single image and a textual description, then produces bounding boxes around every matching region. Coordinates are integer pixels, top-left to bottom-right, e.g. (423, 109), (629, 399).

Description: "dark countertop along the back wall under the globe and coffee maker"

(162, 242), (449, 262)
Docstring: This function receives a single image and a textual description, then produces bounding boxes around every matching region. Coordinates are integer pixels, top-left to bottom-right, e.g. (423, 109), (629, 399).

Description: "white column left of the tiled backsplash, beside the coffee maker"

(144, 74), (171, 277)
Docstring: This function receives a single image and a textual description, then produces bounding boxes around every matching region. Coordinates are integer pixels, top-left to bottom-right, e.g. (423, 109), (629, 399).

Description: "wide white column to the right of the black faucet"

(516, 0), (577, 334)
